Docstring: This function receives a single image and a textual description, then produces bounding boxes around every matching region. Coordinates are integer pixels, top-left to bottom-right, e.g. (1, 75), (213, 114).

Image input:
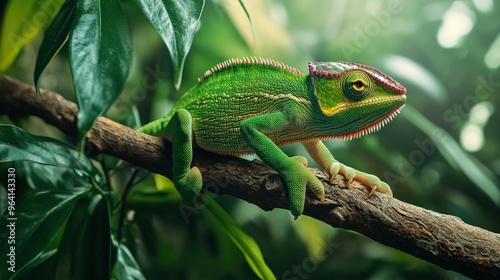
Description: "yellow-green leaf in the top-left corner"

(0, 0), (64, 72)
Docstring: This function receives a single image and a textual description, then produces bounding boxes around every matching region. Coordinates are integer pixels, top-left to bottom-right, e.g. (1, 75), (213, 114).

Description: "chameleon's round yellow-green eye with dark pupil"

(340, 71), (373, 101)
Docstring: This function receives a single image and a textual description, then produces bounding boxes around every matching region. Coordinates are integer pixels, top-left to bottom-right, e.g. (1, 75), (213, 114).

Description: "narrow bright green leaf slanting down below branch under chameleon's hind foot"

(203, 195), (276, 279)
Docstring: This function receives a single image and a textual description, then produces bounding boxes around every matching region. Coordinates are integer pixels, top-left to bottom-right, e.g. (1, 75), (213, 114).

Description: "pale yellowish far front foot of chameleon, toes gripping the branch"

(328, 161), (392, 197)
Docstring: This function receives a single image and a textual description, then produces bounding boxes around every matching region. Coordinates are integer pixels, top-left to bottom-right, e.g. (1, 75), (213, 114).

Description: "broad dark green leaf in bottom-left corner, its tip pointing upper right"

(0, 188), (89, 279)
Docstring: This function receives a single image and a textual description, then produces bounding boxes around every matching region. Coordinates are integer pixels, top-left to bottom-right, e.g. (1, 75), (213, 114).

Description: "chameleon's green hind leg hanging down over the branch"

(168, 109), (203, 203)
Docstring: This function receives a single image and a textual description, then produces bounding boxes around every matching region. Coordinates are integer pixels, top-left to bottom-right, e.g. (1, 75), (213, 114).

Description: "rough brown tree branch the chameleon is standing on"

(0, 75), (500, 279)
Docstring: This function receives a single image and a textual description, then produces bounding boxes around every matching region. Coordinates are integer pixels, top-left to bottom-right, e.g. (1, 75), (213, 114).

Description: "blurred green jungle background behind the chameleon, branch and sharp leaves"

(3, 0), (500, 279)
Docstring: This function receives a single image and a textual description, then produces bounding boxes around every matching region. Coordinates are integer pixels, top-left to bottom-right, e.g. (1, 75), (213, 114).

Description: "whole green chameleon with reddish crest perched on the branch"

(139, 57), (406, 218)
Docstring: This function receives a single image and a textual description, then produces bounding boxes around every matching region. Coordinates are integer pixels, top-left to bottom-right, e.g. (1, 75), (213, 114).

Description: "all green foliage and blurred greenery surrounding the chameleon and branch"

(0, 0), (500, 279)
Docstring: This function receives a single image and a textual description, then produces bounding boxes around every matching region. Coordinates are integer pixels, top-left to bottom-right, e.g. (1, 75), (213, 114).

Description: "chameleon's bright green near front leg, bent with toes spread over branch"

(240, 112), (324, 218)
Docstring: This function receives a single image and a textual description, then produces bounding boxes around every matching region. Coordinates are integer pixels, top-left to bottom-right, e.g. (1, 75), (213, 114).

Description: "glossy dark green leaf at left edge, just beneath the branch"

(0, 125), (92, 174)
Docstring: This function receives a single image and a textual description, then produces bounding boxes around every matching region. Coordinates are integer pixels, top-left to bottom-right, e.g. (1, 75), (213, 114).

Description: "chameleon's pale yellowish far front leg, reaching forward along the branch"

(302, 141), (392, 197)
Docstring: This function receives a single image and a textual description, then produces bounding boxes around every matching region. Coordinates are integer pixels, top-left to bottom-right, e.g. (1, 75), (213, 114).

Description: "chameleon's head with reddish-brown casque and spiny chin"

(309, 62), (406, 139)
